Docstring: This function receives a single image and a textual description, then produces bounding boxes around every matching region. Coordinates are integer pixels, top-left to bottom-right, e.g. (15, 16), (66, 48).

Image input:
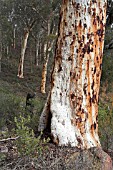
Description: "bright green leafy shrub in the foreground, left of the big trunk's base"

(13, 115), (49, 157)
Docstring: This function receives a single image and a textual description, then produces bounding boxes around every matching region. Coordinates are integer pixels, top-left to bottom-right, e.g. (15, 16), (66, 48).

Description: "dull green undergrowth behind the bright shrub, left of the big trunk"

(0, 81), (44, 132)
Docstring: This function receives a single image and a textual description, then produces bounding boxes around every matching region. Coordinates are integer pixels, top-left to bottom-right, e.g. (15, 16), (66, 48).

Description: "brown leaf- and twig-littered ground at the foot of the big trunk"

(0, 143), (113, 170)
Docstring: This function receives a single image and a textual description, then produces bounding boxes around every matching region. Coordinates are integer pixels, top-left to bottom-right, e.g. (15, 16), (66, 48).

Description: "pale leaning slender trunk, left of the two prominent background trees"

(17, 31), (29, 78)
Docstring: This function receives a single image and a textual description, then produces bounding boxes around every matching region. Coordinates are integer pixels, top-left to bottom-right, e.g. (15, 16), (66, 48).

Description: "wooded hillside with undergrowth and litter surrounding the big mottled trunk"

(0, 0), (113, 170)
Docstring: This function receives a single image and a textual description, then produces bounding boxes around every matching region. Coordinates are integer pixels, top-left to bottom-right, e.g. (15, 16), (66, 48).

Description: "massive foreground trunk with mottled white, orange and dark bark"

(39, 0), (107, 149)
